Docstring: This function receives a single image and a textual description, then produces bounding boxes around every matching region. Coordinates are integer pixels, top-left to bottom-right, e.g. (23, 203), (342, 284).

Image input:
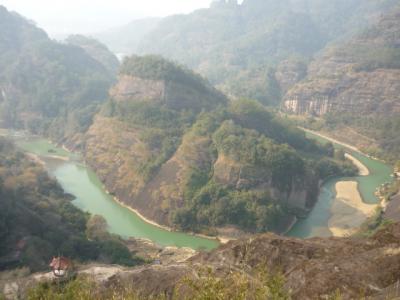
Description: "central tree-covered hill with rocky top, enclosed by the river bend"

(84, 56), (355, 233)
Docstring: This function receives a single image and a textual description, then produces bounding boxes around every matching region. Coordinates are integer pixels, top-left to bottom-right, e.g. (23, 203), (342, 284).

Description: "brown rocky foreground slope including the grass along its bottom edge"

(7, 224), (400, 300)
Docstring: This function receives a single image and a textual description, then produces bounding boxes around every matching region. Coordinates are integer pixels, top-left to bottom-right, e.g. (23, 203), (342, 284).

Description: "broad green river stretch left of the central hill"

(16, 138), (219, 250)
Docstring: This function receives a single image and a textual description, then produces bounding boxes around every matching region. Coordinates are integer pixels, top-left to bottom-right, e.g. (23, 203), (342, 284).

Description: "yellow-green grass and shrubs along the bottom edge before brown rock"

(27, 268), (291, 300)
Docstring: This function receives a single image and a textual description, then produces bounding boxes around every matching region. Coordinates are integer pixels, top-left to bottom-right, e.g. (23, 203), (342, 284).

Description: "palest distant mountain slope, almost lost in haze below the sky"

(92, 18), (161, 56)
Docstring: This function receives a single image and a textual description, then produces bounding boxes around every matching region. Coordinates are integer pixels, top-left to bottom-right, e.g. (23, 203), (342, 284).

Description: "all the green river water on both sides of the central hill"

(13, 133), (392, 246)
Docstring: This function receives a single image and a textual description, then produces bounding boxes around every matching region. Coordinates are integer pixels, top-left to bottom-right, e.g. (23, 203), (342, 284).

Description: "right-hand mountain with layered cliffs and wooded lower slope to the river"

(283, 7), (400, 160)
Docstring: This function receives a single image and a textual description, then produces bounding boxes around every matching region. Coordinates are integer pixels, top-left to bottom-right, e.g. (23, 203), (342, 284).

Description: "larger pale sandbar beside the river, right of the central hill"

(328, 181), (378, 237)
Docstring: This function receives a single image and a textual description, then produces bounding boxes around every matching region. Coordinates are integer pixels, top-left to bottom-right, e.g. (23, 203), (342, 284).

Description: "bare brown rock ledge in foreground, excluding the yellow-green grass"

(1, 223), (400, 299)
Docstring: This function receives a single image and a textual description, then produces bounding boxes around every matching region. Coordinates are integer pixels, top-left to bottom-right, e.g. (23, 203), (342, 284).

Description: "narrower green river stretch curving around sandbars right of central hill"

(287, 132), (393, 238)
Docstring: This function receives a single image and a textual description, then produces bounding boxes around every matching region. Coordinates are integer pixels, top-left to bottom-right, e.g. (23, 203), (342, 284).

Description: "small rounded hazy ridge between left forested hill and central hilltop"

(65, 34), (119, 75)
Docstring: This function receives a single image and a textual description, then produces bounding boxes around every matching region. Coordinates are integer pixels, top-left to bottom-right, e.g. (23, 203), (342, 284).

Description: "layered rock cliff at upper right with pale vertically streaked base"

(283, 9), (400, 116)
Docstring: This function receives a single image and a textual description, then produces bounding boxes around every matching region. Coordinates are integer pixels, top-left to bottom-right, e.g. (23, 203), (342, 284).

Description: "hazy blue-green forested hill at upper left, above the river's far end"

(0, 6), (114, 144)
